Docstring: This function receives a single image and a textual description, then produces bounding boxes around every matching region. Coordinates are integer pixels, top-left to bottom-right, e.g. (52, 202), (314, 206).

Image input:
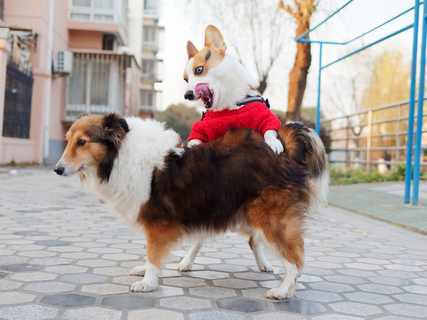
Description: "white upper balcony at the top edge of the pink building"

(68, 0), (127, 45)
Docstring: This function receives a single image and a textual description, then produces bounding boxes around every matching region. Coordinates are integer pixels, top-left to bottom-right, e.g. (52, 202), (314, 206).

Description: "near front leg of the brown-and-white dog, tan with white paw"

(131, 221), (182, 292)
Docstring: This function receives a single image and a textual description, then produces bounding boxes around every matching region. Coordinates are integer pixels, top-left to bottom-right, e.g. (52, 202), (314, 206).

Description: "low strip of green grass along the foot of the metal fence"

(329, 165), (427, 185)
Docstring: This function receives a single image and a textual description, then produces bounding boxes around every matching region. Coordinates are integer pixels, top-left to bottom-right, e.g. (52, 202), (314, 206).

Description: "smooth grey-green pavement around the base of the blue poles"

(328, 181), (427, 235)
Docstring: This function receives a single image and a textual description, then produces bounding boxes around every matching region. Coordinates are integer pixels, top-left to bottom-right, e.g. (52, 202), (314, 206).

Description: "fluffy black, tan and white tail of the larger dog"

(278, 123), (329, 211)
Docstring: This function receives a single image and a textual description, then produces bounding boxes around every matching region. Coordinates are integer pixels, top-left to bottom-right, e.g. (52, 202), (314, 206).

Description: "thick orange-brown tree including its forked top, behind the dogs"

(279, 0), (320, 121)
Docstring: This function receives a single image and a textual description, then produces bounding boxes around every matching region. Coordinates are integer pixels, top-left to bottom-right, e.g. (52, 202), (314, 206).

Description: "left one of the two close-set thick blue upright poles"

(404, 0), (420, 203)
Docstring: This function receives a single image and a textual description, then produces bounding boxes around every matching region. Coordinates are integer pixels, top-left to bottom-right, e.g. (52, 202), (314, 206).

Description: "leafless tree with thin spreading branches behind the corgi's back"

(188, 0), (291, 94)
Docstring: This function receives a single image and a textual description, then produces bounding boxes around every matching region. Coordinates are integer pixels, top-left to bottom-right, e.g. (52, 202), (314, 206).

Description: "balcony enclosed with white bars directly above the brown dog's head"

(63, 52), (131, 122)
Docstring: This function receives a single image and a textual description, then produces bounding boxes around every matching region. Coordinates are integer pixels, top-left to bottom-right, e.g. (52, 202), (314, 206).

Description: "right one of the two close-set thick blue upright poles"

(412, 4), (427, 206)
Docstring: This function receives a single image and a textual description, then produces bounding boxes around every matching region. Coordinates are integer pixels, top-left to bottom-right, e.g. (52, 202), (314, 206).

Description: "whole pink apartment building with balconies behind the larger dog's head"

(0, 0), (161, 164)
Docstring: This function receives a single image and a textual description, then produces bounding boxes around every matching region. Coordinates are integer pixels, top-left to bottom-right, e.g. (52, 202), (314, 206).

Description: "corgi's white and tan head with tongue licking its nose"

(184, 25), (258, 111)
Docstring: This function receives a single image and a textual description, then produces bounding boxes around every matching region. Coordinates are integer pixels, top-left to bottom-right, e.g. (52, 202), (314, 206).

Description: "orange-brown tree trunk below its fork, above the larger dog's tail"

(286, 18), (311, 121)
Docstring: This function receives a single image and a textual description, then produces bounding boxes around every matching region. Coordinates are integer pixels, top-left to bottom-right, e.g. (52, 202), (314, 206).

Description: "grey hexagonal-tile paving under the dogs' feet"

(0, 168), (427, 320)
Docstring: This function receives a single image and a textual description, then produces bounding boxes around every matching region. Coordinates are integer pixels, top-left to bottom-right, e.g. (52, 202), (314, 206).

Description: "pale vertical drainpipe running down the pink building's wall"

(43, 0), (54, 162)
